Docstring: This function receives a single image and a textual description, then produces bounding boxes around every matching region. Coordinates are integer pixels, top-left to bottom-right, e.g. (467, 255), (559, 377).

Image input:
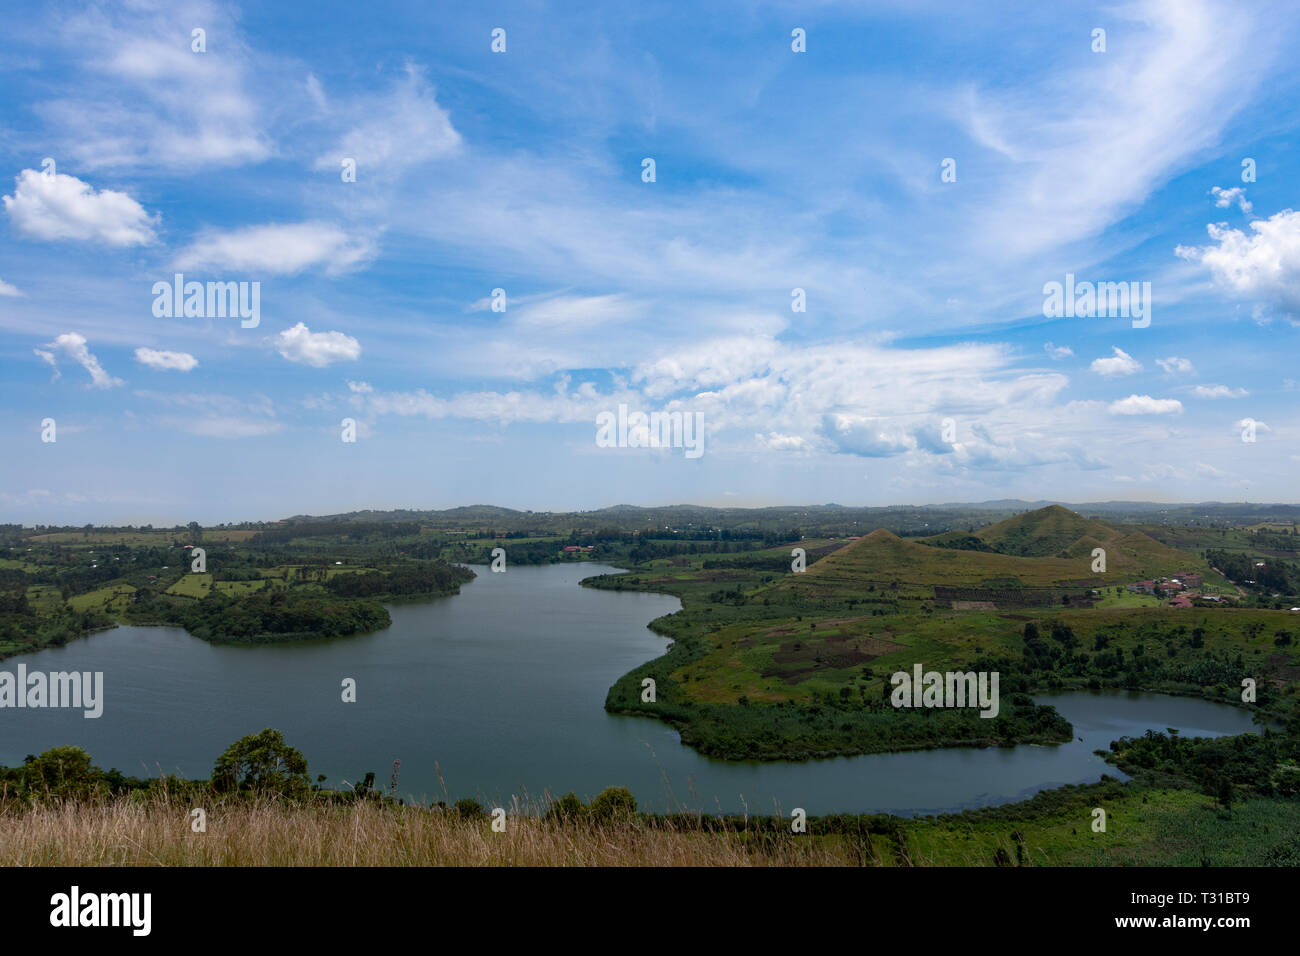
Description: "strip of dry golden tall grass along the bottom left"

(0, 795), (850, 866)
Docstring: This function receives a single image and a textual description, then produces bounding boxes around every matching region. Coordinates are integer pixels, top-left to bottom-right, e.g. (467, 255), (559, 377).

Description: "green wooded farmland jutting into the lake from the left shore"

(0, 525), (473, 657)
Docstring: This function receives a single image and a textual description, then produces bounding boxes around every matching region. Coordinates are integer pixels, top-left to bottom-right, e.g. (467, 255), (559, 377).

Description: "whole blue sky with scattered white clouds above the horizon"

(0, 0), (1300, 525)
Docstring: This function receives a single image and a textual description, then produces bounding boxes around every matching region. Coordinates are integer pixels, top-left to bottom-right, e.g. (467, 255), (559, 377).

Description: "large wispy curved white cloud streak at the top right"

(967, 0), (1270, 252)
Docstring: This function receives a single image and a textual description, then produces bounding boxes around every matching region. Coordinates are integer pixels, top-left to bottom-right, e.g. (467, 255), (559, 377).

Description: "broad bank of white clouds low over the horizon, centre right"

(351, 334), (1097, 473)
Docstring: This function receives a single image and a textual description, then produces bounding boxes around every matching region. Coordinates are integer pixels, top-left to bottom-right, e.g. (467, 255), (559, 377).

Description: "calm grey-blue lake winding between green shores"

(0, 563), (1255, 814)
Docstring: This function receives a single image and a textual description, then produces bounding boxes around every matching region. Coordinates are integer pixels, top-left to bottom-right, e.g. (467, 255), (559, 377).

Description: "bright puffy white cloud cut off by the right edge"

(1174, 209), (1300, 316)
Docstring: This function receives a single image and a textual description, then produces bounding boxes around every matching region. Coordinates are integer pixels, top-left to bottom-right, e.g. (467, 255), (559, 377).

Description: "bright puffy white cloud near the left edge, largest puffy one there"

(4, 169), (157, 246)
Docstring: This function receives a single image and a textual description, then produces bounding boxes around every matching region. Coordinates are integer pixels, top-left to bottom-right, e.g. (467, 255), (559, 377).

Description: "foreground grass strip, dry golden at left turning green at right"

(0, 780), (1300, 866)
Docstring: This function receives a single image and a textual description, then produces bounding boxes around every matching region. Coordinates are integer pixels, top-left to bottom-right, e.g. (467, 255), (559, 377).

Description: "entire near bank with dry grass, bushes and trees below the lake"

(0, 728), (1300, 866)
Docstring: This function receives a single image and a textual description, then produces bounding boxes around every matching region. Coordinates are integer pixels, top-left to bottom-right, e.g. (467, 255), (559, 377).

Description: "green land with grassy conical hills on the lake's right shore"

(584, 509), (1300, 760)
